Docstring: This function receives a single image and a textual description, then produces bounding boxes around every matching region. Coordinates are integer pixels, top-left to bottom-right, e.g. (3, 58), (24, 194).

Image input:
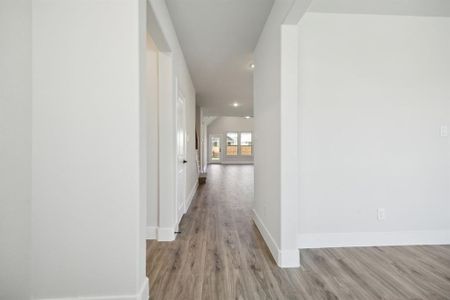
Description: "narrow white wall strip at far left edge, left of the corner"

(0, 0), (31, 300)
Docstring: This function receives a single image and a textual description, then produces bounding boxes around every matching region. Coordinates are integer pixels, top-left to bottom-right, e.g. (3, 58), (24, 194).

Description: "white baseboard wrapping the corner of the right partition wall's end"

(252, 209), (300, 268)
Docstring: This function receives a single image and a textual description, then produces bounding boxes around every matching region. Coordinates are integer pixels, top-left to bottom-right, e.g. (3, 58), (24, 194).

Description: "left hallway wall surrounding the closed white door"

(149, 0), (198, 240)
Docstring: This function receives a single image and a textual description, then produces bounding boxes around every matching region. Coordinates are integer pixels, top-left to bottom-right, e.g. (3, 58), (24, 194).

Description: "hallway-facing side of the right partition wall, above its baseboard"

(253, 0), (293, 253)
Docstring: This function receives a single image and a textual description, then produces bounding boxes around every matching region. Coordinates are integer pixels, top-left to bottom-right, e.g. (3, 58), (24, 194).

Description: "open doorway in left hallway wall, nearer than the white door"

(143, 2), (178, 241)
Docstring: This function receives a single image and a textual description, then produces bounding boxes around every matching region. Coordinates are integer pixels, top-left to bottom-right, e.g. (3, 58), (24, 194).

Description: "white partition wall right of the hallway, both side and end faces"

(253, 0), (310, 267)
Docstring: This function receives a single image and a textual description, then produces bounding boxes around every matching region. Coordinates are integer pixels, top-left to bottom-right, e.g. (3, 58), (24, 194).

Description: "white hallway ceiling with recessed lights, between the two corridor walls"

(166, 0), (273, 116)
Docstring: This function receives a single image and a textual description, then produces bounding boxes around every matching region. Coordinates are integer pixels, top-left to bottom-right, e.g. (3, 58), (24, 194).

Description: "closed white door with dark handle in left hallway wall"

(176, 91), (187, 223)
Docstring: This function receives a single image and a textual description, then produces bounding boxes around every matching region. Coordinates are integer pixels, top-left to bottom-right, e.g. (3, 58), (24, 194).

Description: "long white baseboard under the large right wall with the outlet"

(297, 230), (450, 249)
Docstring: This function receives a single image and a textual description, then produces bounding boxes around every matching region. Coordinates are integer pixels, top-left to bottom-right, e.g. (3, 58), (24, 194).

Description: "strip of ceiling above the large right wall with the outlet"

(309, 0), (450, 17)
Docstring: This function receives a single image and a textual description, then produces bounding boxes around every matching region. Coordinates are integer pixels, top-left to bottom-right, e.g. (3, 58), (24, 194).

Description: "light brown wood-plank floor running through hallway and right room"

(147, 165), (450, 300)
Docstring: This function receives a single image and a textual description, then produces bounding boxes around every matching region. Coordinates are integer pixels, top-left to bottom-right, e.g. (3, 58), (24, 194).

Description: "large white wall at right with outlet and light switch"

(298, 13), (450, 248)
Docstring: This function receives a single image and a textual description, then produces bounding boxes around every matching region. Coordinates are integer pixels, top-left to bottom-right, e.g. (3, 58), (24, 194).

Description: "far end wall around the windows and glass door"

(207, 117), (254, 164)
